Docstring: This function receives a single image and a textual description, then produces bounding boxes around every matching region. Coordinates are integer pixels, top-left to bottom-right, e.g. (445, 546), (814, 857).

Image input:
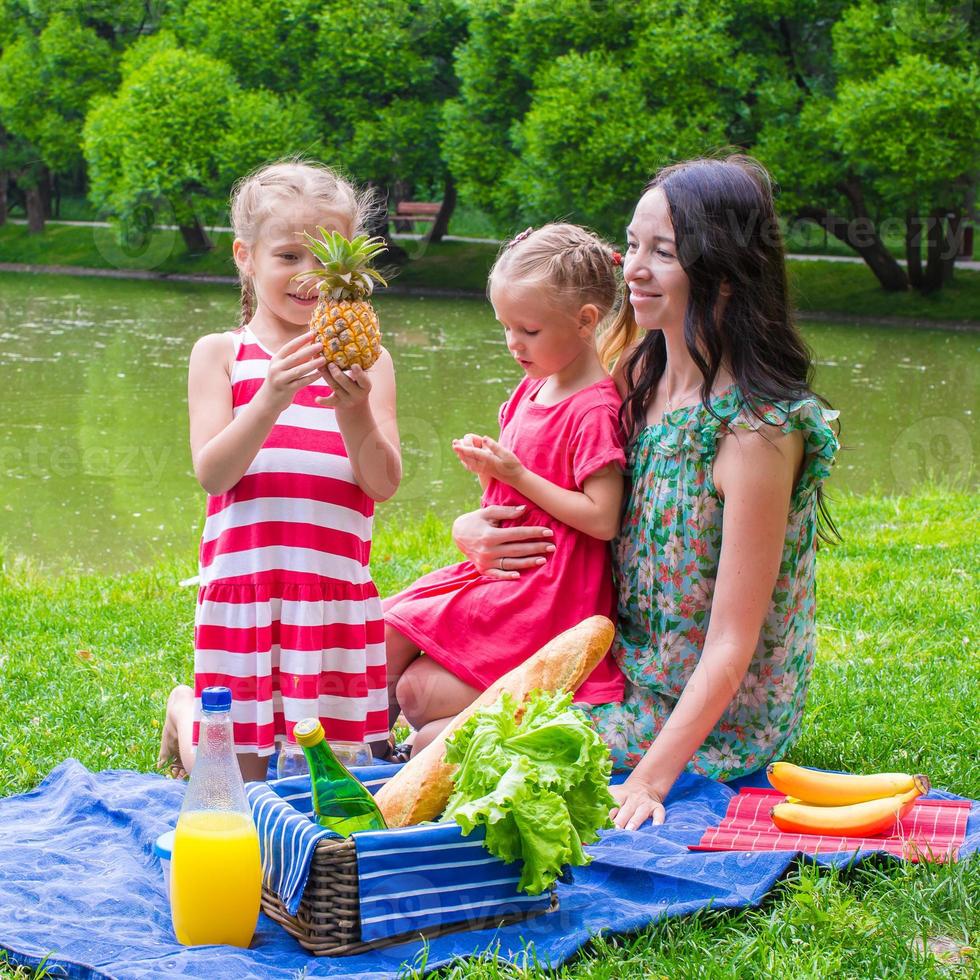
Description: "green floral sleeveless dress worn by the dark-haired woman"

(578, 386), (838, 780)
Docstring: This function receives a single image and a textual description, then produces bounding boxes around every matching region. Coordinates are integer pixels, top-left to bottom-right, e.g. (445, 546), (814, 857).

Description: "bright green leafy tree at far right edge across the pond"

(834, 0), (980, 292)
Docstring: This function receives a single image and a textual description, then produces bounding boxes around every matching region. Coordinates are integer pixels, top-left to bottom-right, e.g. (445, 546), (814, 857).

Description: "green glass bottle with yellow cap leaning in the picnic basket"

(293, 718), (388, 837)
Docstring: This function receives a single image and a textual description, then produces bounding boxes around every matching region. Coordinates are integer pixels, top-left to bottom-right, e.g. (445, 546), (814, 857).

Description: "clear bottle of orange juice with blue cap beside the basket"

(170, 687), (262, 947)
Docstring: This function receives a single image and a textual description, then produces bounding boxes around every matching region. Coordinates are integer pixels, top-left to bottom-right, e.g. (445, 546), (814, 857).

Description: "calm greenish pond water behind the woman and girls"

(0, 273), (980, 572)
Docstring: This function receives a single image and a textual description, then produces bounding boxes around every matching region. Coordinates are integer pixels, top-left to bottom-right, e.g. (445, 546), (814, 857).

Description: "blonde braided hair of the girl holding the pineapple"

(231, 157), (378, 324)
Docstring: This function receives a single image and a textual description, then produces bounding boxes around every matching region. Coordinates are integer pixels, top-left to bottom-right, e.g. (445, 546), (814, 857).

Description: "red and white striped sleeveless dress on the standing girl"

(194, 327), (388, 755)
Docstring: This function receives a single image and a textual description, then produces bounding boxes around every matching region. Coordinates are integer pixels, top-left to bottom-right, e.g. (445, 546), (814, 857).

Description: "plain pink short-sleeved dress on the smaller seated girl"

(385, 378), (626, 704)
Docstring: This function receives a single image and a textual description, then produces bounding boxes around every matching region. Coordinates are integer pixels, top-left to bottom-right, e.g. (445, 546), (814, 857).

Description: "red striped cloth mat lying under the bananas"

(688, 788), (971, 861)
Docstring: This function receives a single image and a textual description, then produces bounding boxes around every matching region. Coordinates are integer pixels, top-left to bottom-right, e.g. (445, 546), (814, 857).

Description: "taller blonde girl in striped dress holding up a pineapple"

(159, 162), (401, 780)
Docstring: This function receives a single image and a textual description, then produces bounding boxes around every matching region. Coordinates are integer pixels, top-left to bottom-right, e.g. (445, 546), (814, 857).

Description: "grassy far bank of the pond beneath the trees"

(0, 224), (980, 330)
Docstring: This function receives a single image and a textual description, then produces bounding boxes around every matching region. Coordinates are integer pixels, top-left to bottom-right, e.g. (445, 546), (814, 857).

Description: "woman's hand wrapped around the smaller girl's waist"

(453, 504), (555, 579)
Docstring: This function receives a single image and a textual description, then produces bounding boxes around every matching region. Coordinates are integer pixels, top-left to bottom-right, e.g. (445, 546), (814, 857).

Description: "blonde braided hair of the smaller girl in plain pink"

(487, 222), (619, 319)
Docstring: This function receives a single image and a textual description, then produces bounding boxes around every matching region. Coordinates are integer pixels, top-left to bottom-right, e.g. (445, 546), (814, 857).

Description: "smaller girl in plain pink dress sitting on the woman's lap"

(385, 224), (626, 751)
